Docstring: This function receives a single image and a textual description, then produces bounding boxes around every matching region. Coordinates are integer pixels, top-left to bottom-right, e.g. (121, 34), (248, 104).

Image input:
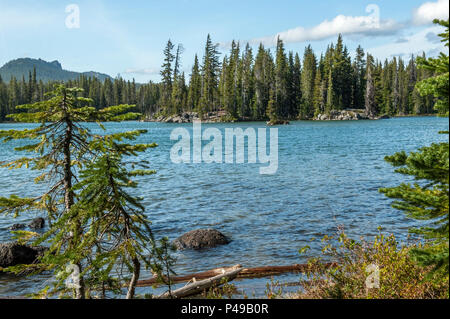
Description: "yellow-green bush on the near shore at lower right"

(296, 232), (449, 299)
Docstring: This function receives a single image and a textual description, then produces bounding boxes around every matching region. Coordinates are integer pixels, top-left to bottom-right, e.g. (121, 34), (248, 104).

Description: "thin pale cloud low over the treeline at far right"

(367, 26), (448, 60)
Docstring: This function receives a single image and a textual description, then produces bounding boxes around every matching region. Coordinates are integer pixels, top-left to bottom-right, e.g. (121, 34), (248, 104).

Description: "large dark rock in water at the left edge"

(0, 243), (45, 268)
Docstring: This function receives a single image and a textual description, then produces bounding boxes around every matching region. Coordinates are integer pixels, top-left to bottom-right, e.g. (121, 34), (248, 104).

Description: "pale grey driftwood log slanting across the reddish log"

(158, 267), (243, 299)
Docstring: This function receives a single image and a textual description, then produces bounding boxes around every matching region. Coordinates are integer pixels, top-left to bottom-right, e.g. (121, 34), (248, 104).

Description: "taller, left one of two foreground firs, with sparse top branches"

(0, 84), (158, 299)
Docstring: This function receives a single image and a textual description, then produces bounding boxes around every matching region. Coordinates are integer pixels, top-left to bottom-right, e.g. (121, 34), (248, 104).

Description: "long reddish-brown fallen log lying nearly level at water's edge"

(136, 263), (336, 287)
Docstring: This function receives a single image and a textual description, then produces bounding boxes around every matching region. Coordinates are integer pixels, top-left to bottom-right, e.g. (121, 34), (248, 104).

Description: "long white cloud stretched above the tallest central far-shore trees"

(251, 8), (403, 45)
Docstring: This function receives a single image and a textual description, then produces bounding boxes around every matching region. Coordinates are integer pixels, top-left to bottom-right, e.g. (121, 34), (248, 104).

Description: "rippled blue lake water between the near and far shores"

(0, 117), (448, 297)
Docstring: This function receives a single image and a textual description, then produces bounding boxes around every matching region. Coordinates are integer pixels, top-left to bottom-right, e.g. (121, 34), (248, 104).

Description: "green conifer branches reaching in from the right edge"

(380, 20), (449, 277)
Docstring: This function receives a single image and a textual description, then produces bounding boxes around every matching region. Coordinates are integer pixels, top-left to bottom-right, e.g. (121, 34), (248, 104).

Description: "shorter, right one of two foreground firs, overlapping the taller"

(72, 135), (158, 299)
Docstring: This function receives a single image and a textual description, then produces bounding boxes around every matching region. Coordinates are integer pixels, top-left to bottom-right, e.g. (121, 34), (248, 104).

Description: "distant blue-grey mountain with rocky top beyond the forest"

(0, 58), (111, 82)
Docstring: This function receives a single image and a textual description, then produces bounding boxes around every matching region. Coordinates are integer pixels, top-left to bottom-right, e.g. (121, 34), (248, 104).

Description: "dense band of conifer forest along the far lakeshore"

(0, 35), (434, 121)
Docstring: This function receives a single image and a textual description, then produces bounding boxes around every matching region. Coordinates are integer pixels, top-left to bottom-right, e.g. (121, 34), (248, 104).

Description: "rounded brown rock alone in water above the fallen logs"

(173, 228), (230, 250)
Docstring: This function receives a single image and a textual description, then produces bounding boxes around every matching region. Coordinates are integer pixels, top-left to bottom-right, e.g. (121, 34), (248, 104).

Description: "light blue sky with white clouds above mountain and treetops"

(0, 0), (449, 83)
